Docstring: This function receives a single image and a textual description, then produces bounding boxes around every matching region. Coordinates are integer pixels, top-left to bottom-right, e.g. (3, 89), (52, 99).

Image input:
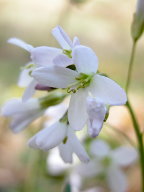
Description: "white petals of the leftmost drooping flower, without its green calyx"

(2, 98), (44, 133)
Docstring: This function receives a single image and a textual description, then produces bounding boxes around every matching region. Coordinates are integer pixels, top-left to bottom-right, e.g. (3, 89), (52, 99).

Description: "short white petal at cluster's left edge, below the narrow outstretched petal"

(18, 63), (33, 87)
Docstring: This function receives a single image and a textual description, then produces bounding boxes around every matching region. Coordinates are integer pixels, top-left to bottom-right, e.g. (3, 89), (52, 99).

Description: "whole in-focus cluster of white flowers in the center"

(2, 26), (127, 163)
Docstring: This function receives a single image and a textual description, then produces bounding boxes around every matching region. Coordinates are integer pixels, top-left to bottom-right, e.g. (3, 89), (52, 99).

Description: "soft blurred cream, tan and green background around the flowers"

(0, 0), (144, 192)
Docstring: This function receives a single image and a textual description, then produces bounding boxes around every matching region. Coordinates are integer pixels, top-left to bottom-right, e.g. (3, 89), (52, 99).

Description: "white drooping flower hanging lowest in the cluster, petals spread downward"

(28, 122), (89, 163)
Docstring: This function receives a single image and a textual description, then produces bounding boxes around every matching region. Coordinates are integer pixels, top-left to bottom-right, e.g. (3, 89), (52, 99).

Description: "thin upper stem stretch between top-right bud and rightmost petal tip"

(125, 41), (137, 93)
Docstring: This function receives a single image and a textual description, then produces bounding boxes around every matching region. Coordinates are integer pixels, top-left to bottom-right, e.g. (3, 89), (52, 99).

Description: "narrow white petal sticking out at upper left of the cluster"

(8, 38), (33, 52)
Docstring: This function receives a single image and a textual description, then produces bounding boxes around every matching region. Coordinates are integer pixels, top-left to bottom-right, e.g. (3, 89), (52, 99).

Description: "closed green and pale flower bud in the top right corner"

(131, 0), (144, 41)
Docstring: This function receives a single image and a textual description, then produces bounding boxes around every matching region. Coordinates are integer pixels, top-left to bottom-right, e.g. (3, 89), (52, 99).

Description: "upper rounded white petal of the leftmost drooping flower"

(2, 98), (40, 116)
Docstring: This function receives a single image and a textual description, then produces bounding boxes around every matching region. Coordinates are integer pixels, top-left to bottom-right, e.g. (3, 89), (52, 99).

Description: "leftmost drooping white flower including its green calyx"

(1, 93), (66, 133)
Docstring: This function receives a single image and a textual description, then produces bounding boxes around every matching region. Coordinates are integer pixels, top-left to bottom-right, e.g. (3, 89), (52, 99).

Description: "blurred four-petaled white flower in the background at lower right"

(77, 139), (138, 192)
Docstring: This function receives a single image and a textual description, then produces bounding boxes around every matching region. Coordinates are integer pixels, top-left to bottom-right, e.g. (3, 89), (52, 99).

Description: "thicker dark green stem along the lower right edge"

(126, 101), (144, 192)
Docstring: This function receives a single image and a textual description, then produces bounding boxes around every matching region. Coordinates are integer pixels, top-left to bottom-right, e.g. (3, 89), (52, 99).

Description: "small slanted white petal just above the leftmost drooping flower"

(22, 79), (37, 102)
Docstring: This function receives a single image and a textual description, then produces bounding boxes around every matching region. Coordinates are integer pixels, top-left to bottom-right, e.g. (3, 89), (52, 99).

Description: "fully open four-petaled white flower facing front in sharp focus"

(32, 46), (127, 130)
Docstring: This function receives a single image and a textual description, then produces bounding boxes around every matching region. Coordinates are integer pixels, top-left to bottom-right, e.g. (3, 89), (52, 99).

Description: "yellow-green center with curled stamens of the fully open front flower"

(67, 73), (94, 93)
